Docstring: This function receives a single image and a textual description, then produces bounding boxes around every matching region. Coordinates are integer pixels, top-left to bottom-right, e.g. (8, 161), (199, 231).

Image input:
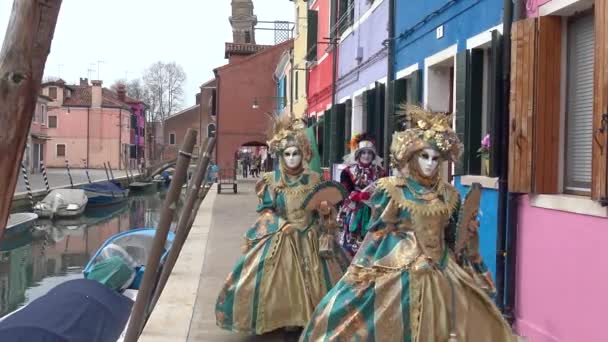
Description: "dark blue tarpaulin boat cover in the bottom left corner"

(0, 279), (133, 342)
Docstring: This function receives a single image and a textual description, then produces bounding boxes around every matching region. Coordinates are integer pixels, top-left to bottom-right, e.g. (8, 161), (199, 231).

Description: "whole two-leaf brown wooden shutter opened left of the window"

(509, 16), (561, 194)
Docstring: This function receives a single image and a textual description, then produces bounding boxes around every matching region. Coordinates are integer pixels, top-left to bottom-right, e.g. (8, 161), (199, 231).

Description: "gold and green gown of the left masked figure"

(215, 171), (349, 334)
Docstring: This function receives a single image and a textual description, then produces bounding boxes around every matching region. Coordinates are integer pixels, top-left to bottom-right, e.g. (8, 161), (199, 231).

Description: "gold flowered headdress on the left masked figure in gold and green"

(267, 114), (312, 163)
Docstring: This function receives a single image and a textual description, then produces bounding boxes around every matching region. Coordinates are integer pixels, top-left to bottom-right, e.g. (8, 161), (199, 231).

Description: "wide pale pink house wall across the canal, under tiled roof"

(45, 108), (130, 168)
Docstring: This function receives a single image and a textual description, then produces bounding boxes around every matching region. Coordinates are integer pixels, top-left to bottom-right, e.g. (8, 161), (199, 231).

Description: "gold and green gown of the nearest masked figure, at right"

(301, 177), (515, 342)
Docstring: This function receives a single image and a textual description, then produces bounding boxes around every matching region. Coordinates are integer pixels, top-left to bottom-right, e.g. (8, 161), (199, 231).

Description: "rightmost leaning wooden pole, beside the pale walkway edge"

(147, 138), (215, 316)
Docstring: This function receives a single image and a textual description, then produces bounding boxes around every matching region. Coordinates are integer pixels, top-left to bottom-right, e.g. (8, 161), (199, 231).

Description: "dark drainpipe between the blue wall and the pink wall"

(495, 0), (513, 322)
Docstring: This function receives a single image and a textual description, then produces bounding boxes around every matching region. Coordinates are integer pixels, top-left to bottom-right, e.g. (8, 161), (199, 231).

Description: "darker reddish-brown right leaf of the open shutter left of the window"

(532, 16), (562, 194)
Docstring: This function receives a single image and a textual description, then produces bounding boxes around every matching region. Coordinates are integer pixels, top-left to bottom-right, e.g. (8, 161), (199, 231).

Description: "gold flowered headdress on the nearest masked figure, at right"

(391, 104), (463, 164)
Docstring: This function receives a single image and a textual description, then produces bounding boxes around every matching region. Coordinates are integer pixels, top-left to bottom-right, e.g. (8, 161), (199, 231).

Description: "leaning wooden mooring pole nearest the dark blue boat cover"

(125, 128), (196, 342)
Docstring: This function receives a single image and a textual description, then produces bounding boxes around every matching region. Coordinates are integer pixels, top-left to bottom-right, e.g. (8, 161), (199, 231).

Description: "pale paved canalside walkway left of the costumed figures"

(140, 179), (298, 342)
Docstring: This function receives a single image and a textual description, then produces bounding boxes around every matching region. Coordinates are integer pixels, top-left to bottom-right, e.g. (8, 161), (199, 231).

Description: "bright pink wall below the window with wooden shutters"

(516, 196), (608, 342)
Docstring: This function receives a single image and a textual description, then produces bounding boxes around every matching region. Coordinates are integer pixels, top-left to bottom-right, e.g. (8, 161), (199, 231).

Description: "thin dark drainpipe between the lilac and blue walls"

(383, 0), (396, 171)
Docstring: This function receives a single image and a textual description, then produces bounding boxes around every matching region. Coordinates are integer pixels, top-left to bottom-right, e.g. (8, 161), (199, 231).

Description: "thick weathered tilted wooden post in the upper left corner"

(0, 0), (61, 240)
